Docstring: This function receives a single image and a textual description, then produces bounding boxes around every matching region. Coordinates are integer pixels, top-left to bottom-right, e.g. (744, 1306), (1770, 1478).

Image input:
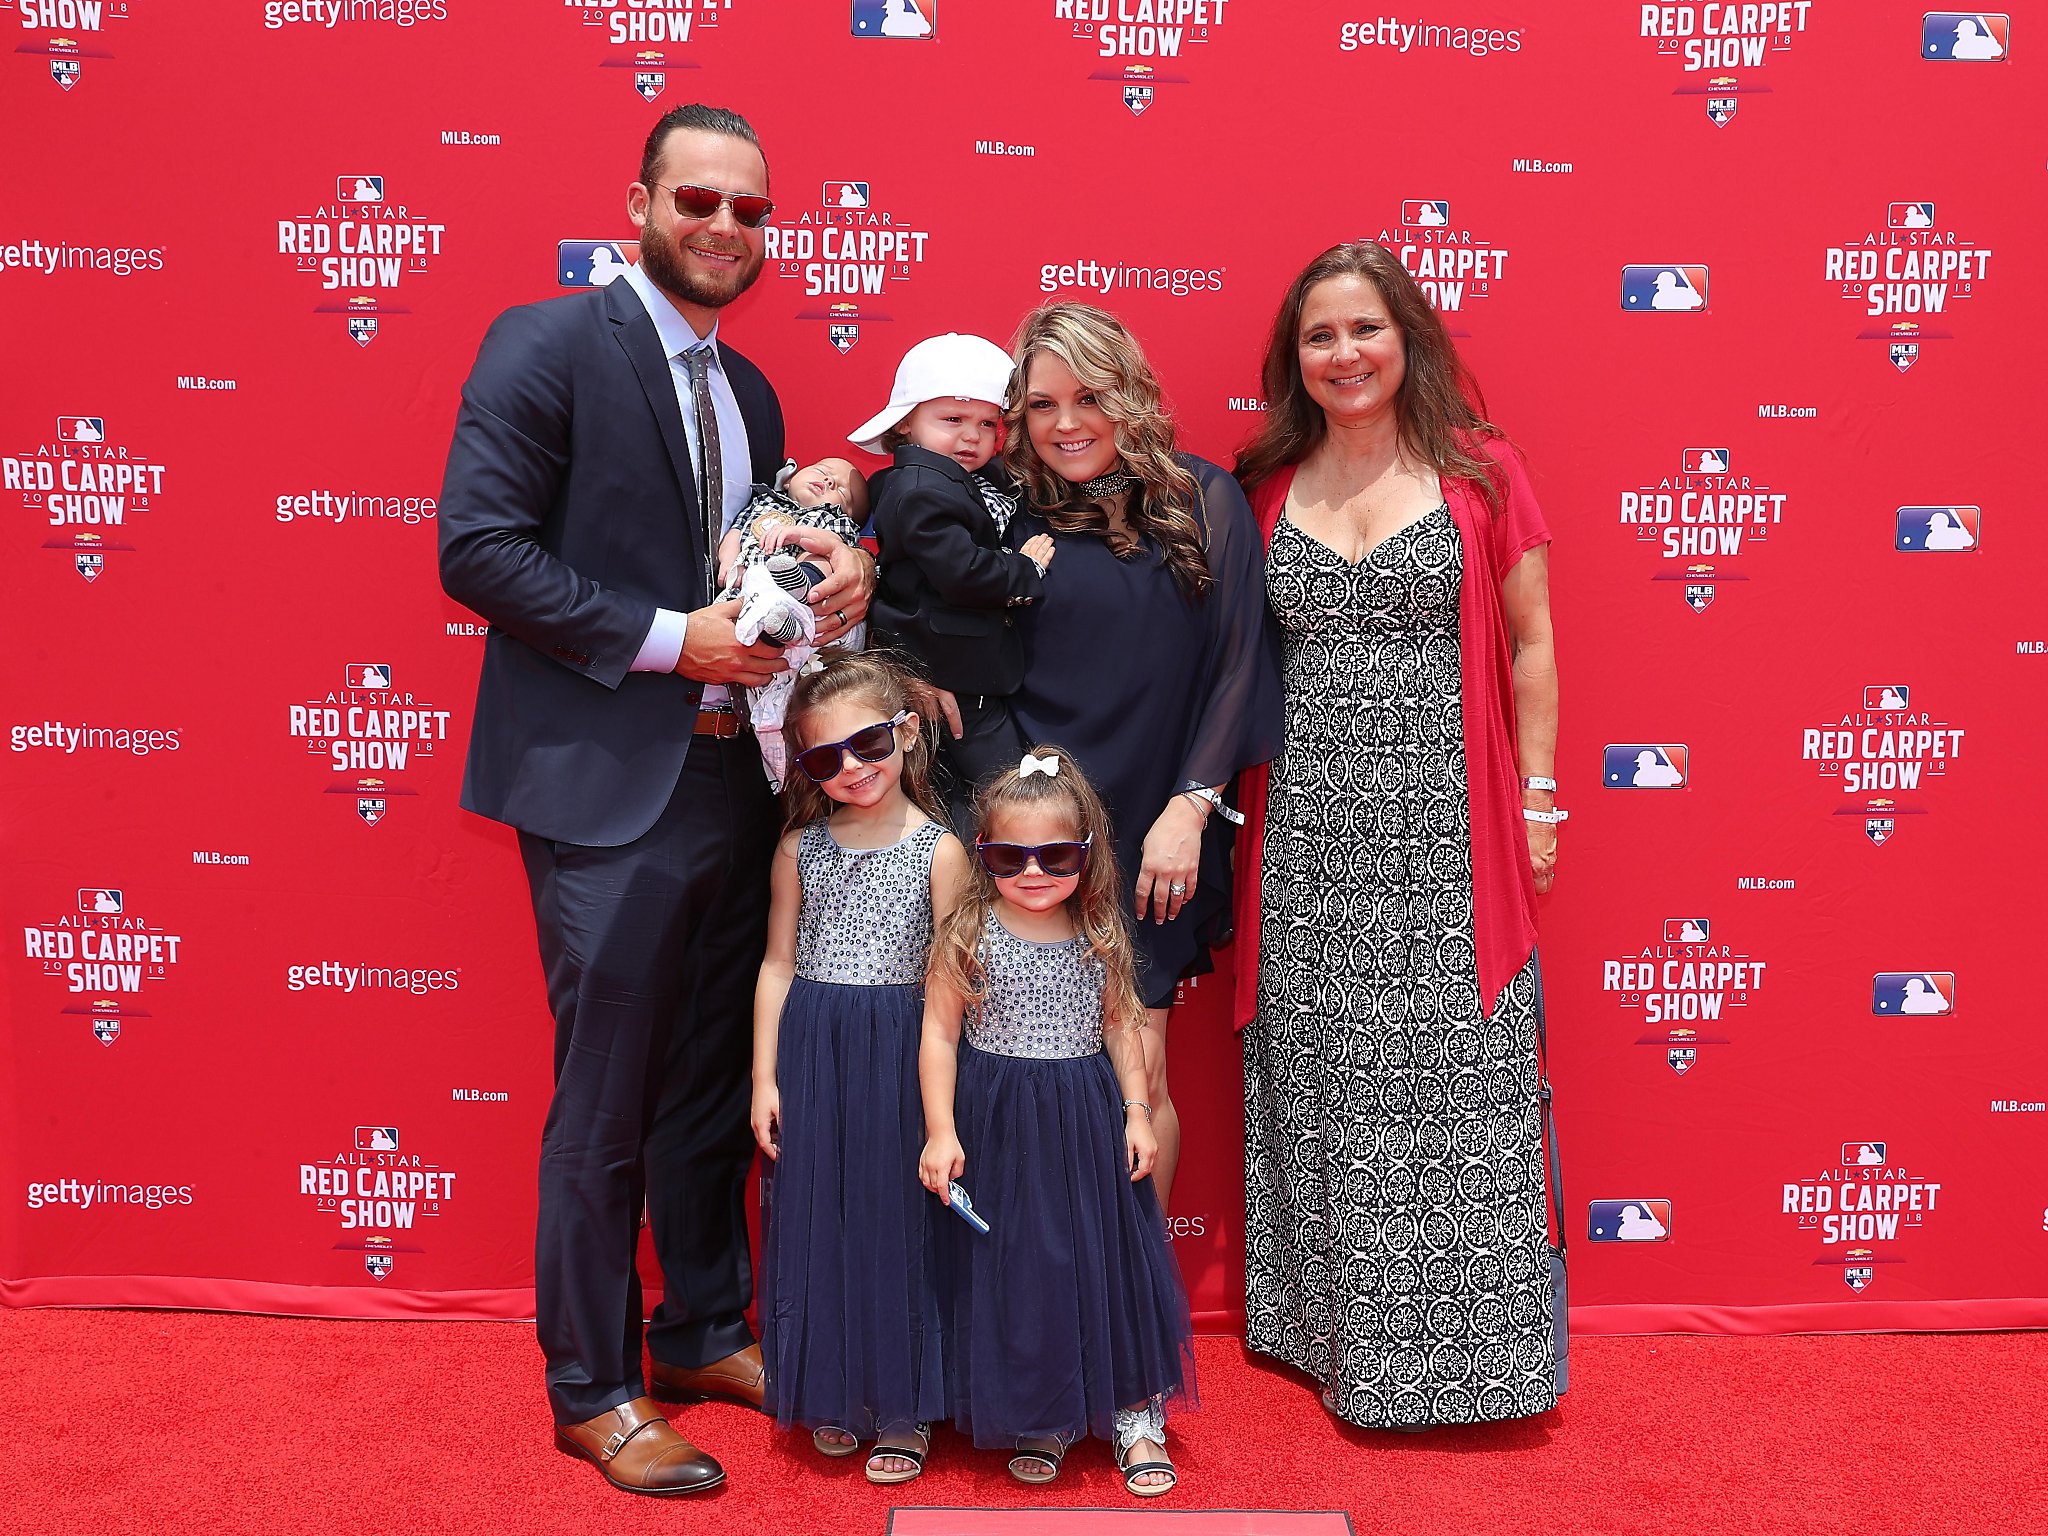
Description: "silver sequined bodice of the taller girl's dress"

(797, 821), (946, 987)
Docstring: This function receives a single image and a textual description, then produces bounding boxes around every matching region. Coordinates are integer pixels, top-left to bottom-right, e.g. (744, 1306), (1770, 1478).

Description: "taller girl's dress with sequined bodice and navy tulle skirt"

(760, 821), (952, 1440)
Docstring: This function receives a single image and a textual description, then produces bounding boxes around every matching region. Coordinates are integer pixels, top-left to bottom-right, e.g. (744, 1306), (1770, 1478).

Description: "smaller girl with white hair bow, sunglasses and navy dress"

(918, 745), (1194, 1499)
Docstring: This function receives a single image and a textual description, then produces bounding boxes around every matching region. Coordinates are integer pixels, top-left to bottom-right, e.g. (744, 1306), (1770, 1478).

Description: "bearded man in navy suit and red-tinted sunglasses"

(440, 104), (872, 1493)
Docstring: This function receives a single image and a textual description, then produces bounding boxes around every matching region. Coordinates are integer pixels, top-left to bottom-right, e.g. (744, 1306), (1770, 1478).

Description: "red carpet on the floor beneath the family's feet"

(0, 1311), (2048, 1536)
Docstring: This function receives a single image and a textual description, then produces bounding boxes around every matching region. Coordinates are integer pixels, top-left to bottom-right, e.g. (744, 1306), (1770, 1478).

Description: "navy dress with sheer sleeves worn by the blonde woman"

(1010, 455), (1282, 1008)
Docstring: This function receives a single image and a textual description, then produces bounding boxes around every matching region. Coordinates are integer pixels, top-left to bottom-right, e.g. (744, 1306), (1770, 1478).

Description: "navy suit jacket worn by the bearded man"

(438, 283), (782, 848)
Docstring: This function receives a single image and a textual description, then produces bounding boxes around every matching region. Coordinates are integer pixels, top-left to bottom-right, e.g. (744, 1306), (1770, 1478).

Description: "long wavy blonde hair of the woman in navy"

(1004, 303), (1210, 598)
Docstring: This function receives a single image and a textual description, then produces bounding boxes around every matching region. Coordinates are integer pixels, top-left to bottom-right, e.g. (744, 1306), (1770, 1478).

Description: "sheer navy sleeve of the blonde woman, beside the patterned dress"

(1180, 459), (1282, 784)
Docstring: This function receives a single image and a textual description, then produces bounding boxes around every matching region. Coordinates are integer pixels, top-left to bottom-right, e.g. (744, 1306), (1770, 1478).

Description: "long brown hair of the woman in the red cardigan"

(1235, 240), (1507, 516)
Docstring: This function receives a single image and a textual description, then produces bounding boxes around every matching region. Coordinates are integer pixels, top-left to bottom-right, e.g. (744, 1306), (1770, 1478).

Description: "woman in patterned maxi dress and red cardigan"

(1239, 246), (1556, 1430)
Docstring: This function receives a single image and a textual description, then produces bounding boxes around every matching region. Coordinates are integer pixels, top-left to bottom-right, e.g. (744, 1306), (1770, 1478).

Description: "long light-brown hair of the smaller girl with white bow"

(928, 743), (1145, 1028)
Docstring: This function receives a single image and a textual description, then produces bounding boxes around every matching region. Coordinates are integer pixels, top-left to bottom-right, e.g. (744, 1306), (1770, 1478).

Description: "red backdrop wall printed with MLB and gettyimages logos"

(0, 0), (2048, 1331)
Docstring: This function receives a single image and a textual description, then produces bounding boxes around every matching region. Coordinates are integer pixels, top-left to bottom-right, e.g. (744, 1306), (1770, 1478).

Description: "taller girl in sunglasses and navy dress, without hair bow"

(754, 651), (967, 1483)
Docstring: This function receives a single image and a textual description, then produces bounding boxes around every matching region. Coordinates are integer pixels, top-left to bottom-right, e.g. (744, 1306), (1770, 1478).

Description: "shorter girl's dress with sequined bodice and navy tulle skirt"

(934, 911), (1194, 1448)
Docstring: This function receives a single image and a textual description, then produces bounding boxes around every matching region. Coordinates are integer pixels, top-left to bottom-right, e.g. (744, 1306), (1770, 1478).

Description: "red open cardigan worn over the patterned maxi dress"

(1235, 440), (1550, 1028)
